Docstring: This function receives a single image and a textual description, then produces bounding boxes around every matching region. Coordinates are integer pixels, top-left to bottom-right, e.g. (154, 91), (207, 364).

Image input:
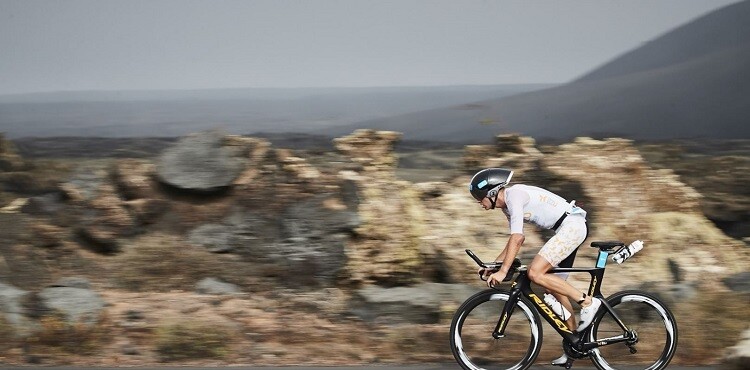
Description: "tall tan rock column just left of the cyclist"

(335, 130), (434, 286)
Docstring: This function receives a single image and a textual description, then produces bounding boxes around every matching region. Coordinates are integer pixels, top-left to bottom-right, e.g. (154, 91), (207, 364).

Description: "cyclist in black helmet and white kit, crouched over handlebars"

(469, 168), (601, 365)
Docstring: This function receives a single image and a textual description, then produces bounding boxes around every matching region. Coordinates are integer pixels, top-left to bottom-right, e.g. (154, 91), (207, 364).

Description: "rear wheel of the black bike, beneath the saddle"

(588, 290), (677, 370)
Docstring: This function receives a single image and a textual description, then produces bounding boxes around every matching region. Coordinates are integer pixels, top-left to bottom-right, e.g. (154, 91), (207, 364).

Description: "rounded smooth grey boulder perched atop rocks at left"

(157, 131), (243, 192)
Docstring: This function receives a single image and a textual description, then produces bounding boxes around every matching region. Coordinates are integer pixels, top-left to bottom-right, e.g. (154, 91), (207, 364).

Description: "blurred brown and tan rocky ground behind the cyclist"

(0, 130), (750, 368)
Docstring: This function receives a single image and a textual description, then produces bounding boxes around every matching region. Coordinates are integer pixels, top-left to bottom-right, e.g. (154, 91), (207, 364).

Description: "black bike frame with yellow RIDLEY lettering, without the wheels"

(492, 251), (634, 351)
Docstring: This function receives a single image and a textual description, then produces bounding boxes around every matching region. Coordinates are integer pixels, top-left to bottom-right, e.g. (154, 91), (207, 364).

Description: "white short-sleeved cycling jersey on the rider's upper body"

(503, 184), (586, 234)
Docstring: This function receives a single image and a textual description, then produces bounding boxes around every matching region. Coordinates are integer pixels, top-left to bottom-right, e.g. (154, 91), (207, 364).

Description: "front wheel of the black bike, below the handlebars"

(450, 289), (542, 370)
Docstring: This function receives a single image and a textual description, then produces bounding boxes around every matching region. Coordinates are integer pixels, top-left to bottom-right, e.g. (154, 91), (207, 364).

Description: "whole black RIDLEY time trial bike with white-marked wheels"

(450, 241), (677, 370)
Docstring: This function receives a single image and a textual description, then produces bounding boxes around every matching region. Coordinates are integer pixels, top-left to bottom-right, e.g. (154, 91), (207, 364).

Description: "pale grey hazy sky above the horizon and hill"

(0, 0), (737, 94)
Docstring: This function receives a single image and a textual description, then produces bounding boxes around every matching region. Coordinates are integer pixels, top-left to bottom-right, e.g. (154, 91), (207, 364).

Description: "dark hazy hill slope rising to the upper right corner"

(326, 1), (750, 143)
